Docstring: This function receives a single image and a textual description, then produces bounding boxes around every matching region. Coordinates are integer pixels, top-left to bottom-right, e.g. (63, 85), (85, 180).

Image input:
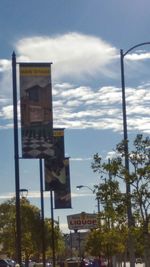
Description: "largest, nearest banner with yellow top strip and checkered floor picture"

(19, 63), (54, 158)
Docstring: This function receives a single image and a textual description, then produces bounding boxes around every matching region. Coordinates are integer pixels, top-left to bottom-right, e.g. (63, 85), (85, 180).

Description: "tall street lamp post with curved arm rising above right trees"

(120, 42), (150, 267)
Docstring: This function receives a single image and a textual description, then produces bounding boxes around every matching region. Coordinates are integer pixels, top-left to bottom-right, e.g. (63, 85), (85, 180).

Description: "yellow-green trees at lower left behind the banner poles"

(0, 198), (61, 262)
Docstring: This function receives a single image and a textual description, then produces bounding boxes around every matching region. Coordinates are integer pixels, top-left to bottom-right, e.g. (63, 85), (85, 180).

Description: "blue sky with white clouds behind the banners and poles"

(0, 0), (150, 232)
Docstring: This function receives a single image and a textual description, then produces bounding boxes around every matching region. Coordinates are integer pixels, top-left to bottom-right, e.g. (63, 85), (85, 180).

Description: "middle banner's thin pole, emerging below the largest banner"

(39, 159), (46, 267)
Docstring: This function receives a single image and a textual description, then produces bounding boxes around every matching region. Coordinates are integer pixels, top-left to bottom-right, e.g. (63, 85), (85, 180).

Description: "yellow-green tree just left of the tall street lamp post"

(91, 163), (128, 266)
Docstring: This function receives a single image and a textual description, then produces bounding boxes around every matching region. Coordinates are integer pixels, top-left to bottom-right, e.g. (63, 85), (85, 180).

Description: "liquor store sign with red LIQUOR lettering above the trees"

(67, 212), (98, 230)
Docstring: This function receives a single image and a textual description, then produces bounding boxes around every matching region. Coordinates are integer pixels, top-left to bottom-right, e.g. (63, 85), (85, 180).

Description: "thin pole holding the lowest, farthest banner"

(50, 190), (56, 267)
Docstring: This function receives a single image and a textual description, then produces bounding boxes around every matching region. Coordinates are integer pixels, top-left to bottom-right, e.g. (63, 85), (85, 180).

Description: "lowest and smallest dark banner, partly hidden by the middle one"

(54, 158), (71, 209)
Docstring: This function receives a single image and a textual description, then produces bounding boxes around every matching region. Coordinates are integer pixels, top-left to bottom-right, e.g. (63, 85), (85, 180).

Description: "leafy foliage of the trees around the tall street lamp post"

(91, 134), (150, 260)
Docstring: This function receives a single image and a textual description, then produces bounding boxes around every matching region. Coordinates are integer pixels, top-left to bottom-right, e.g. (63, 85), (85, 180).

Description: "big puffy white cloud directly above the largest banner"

(16, 32), (117, 79)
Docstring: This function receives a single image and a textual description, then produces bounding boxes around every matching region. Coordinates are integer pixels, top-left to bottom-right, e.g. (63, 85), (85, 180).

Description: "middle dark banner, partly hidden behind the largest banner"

(44, 129), (66, 191)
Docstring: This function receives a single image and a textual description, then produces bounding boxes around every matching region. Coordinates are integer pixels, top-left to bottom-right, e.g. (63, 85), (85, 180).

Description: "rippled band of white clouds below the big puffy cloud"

(0, 80), (150, 133)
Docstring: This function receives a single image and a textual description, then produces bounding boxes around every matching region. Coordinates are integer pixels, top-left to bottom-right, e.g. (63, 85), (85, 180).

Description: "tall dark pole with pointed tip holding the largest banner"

(12, 52), (21, 266)
